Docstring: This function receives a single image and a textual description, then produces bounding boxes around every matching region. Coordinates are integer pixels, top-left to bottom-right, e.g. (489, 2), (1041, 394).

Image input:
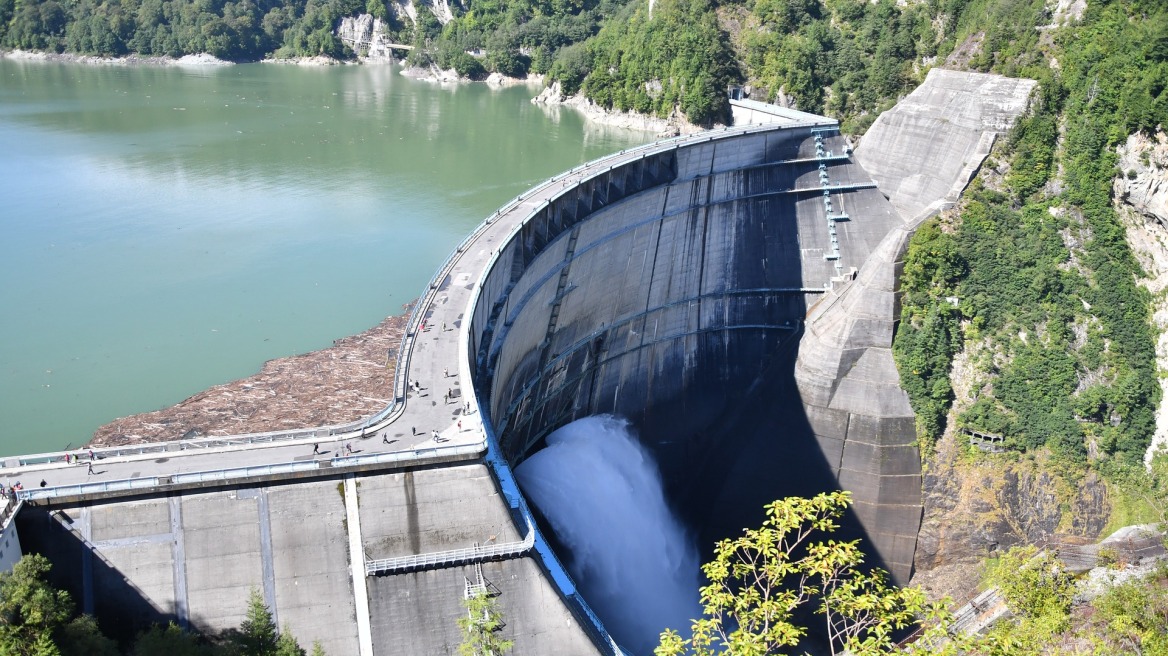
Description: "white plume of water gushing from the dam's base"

(515, 414), (701, 656)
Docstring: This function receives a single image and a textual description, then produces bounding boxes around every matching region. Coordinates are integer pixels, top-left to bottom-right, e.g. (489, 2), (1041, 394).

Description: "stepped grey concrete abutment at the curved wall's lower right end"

(795, 225), (923, 582)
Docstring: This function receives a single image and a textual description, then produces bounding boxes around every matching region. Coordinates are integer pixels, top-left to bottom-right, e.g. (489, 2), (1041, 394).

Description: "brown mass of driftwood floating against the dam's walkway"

(90, 307), (409, 446)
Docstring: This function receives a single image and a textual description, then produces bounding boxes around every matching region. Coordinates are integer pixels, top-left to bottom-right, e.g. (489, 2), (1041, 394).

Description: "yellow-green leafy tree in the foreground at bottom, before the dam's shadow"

(655, 491), (964, 656)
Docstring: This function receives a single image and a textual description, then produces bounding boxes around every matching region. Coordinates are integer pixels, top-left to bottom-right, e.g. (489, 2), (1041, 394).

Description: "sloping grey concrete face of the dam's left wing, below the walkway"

(18, 463), (596, 655)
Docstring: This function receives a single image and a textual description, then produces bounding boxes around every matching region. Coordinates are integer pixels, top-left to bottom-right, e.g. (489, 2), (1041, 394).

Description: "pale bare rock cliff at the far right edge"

(1113, 132), (1168, 460)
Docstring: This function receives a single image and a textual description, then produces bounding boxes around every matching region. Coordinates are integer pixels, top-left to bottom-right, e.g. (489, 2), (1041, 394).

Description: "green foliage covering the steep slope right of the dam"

(896, 1), (1168, 462)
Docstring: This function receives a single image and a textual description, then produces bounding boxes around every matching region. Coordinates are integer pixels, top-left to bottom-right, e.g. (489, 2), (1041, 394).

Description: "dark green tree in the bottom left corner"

(0, 553), (72, 656)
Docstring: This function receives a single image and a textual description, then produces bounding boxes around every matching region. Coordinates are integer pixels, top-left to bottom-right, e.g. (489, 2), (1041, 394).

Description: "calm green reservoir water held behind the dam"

(0, 58), (653, 455)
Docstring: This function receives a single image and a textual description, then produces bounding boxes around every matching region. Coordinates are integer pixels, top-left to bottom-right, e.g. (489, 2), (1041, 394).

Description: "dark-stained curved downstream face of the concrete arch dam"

(468, 124), (920, 580)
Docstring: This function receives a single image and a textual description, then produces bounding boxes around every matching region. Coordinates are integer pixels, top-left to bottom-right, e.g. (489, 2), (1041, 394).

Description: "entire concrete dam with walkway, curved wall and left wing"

(0, 70), (1041, 655)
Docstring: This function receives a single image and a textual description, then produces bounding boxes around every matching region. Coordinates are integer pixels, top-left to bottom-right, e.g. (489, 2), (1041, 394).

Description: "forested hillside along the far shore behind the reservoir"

(0, 0), (1079, 123)
